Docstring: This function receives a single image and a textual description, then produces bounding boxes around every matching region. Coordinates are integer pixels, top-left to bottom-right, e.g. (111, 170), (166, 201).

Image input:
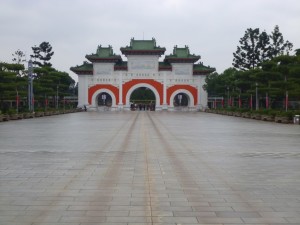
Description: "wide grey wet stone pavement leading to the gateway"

(0, 112), (300, 225)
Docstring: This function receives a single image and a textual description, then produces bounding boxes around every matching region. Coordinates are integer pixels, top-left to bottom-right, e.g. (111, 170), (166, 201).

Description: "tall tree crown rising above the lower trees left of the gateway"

(30, 42), (54, 67)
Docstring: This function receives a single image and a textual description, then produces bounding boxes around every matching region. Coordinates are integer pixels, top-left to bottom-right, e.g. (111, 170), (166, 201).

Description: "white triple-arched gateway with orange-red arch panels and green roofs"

(71, 39), (215, 111)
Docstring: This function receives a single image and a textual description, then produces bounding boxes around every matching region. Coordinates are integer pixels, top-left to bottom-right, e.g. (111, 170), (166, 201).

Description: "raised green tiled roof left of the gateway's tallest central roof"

(85, 45), (122, 62)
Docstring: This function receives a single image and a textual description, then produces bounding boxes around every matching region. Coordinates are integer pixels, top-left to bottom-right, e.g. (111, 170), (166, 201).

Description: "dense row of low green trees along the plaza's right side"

(209, 49), (300, 109)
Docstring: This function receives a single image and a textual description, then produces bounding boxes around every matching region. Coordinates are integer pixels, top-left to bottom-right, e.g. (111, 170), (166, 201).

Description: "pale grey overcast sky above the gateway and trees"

(0, 0), (300, 80)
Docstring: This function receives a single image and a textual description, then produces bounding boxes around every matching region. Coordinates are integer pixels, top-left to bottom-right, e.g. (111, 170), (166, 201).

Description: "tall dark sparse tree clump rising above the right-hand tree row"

(232, 25), (293, 71)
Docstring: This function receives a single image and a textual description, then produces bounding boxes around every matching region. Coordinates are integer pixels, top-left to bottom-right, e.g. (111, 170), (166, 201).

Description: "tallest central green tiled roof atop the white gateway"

(120, 38), (166, 55)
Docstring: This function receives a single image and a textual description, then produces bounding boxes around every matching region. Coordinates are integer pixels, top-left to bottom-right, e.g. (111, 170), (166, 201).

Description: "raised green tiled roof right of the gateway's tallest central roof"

(165, 46), (200, 63)
